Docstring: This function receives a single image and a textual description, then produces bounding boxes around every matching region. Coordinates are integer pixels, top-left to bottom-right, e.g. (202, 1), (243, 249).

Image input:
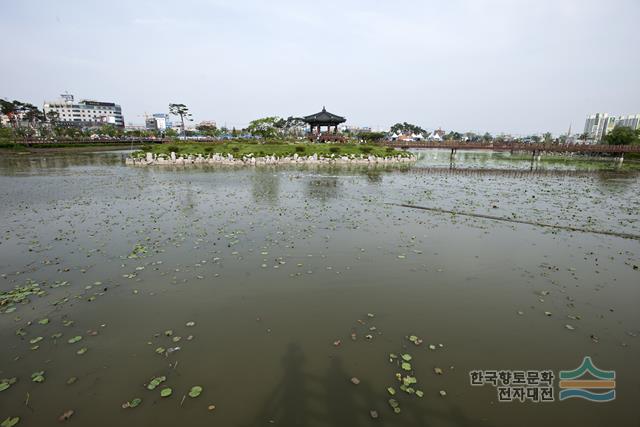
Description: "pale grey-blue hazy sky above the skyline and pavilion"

(0, 0), (640, 134)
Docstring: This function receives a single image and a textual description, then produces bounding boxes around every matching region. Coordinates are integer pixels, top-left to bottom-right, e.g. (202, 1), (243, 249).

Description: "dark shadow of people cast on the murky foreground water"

(247, 343), (496, 427)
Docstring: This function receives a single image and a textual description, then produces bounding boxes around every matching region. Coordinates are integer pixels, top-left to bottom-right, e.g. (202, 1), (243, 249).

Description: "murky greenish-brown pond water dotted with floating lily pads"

(0, 152), (640, 426)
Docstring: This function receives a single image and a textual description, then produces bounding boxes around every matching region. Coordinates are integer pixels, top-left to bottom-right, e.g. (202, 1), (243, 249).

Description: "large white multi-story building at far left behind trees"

(44, 94), (124, 127)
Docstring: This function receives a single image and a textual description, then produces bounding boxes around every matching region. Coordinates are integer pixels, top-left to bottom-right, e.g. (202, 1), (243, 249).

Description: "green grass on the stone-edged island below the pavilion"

(134, 142), (410, 158)
